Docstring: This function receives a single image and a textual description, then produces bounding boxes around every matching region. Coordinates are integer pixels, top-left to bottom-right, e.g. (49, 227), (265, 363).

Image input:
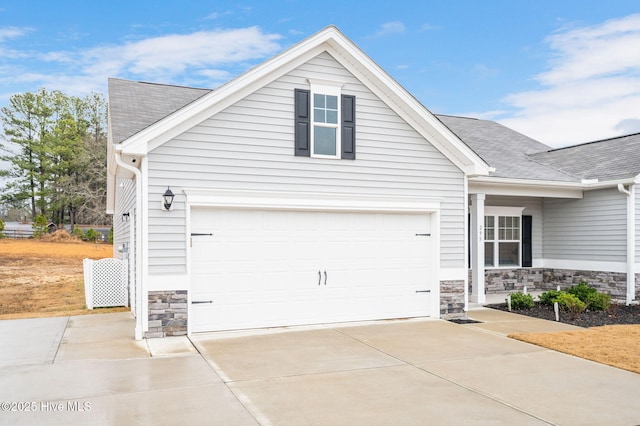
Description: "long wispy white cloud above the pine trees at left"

(0, 27), (281, 99)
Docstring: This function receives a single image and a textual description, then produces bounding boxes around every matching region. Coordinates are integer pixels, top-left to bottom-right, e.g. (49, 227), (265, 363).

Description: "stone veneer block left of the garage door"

(145, 290), (188, 339)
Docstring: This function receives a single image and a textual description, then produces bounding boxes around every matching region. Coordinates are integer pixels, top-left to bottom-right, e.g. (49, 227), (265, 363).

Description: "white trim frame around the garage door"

(184, 188), (440, 335)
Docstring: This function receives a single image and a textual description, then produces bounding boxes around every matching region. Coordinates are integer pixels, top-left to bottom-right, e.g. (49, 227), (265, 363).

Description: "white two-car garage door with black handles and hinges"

(189, 208), (435, 332)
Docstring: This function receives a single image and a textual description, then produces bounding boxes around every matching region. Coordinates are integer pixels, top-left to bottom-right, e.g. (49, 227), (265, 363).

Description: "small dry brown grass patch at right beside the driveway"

(509, 325), (640, 373)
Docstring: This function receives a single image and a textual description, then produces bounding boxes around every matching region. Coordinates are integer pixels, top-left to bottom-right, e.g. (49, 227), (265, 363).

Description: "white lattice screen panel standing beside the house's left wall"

(83, 258), (129, 309)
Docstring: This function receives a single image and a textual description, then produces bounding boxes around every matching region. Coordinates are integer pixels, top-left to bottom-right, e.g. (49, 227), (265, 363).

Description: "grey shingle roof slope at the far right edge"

(531, 133), (640, 181)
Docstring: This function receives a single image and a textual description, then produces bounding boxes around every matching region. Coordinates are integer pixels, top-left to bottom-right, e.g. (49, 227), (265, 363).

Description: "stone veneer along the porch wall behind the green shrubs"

(469, 268), (640, 300)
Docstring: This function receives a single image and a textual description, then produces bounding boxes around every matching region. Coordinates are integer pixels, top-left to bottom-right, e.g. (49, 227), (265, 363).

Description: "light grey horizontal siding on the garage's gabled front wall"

(148, 53), (464, 274)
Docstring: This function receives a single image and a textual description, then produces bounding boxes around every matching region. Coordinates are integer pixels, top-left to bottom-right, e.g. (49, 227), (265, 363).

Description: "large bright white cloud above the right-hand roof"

(499, 14), (640, 146)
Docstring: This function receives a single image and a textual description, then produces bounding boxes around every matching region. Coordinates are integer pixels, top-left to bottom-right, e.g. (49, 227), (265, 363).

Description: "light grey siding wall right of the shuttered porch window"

(543, 188), (627, 262)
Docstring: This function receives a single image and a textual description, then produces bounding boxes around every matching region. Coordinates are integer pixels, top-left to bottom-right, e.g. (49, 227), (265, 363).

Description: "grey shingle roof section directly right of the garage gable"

(436, 115), (580, 182)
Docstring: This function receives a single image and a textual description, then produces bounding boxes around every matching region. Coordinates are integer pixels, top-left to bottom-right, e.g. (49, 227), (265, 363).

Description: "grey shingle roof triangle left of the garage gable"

(109, 78), (211, 143)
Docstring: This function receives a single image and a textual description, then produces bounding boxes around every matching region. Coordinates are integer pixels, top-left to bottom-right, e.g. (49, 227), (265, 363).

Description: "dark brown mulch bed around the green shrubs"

(487, 303), (640, 327)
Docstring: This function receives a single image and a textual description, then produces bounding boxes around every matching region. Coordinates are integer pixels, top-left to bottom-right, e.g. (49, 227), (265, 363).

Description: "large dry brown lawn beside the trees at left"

(0, 236), (129, 319)
